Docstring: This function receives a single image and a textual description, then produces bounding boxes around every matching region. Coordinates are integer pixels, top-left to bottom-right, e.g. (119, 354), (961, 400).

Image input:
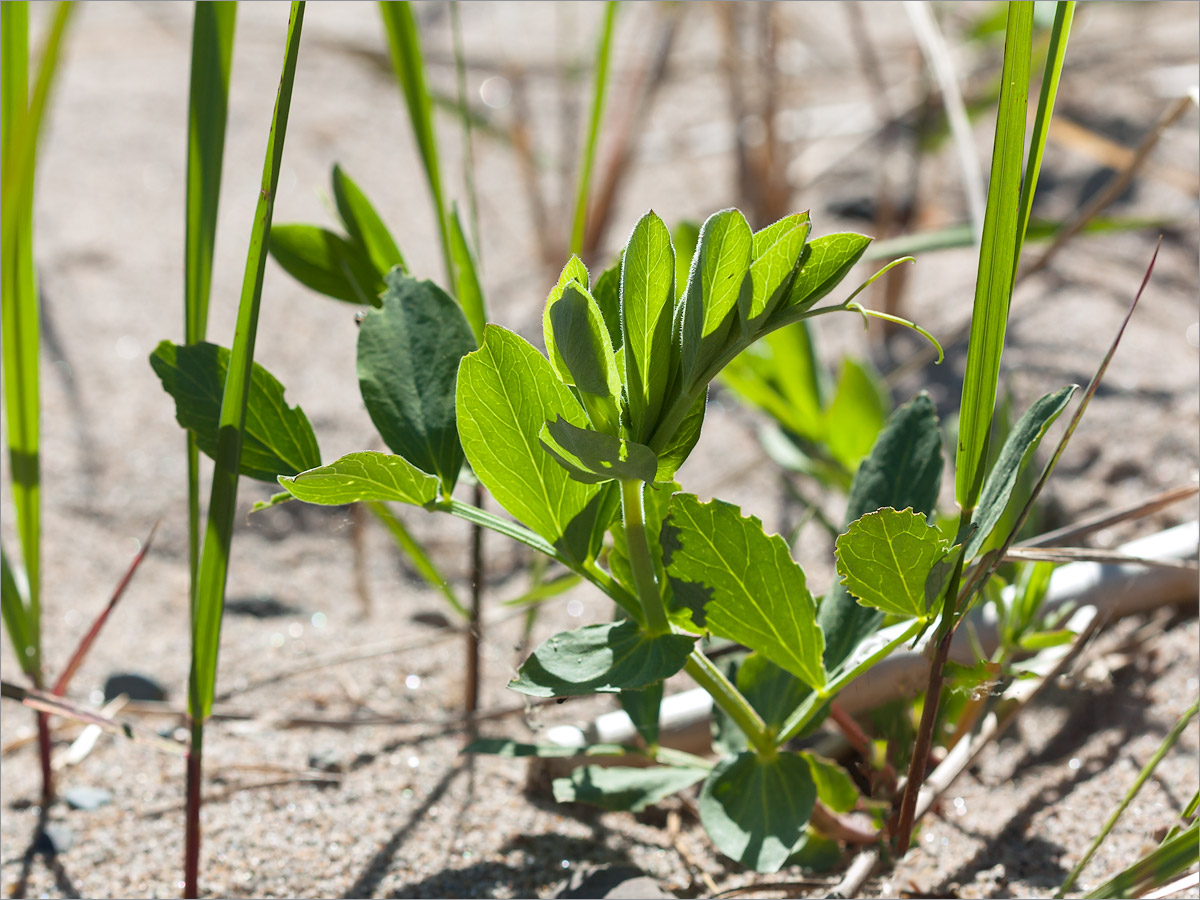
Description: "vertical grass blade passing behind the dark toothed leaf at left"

(184, 0), (238, 604)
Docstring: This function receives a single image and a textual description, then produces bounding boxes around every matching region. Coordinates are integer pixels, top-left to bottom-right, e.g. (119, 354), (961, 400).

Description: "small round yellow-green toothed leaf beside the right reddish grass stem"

(835, 508), (949, 618)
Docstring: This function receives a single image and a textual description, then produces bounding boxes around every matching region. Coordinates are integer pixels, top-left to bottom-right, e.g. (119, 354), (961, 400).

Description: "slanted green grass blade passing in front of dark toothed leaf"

(188, 2), (304, 722)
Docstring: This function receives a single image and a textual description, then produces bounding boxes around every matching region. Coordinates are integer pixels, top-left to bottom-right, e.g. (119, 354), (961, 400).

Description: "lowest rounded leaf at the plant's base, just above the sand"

(700, 751), (817, 872)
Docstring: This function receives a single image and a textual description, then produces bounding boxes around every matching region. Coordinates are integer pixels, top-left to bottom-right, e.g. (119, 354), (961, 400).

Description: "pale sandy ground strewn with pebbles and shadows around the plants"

(0, 2), (1200, 898)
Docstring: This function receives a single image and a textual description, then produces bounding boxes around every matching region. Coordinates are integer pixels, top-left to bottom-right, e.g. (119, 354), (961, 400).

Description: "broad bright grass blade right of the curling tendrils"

(954, 2), (1033, 512)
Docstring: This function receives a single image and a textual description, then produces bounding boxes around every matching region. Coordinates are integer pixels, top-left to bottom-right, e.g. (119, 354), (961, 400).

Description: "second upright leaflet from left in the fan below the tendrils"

(680, 209), (754, 384)
